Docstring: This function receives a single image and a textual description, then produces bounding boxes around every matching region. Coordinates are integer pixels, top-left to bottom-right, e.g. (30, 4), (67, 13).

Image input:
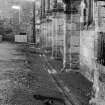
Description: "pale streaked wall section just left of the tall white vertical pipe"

(40, 13), (64, 47)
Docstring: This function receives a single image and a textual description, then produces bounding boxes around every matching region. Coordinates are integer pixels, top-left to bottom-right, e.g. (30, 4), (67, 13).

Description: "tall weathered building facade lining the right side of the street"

(39, 0), (104, 103)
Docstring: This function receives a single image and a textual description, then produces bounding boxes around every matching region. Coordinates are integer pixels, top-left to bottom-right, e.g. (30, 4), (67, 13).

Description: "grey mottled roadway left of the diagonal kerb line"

(0, 42), (64, 105)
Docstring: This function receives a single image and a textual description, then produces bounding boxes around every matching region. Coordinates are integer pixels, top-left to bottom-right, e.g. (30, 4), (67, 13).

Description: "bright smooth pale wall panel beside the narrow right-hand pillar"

(80, 30), (96, 81)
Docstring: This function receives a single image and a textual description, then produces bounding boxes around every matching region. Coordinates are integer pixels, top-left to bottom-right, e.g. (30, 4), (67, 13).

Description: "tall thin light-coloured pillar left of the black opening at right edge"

(90, 1), (100, 105)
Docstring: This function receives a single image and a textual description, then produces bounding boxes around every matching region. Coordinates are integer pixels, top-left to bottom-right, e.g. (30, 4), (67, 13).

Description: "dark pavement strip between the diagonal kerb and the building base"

(41, 47), (92, 105)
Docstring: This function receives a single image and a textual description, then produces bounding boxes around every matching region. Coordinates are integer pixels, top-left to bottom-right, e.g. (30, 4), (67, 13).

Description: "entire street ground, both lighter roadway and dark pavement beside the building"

(0, 42), (91, 105)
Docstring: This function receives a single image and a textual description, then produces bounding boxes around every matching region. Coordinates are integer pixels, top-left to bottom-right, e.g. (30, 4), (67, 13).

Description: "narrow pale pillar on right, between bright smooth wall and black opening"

(91, 0), (100, 99)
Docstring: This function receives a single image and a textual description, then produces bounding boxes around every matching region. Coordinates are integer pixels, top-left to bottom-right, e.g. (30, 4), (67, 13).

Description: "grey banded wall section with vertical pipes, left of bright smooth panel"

(63, 3), (80, 71)
